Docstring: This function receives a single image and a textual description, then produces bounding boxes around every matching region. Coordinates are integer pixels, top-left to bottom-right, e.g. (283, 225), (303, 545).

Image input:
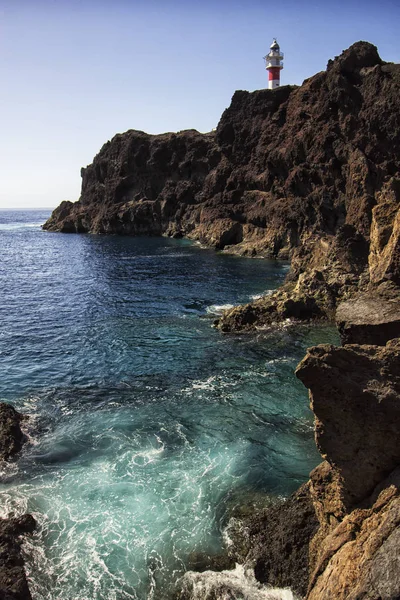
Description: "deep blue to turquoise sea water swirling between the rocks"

(0, 211), (337, 600)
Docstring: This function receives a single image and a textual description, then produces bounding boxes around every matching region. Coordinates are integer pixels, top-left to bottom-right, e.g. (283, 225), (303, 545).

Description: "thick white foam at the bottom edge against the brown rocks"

(180, 565), (296, 600)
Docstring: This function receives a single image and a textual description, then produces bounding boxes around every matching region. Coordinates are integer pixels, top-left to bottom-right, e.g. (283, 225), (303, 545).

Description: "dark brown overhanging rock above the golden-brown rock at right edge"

(296, 339), (400, 509)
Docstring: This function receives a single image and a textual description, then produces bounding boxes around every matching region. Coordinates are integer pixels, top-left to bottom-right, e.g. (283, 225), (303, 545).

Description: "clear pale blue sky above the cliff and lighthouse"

(0, 0), (400, 209)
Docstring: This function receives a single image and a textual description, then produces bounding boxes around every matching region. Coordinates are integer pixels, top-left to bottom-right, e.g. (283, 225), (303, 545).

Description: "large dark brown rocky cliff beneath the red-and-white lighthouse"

(44, 42), (400, 331)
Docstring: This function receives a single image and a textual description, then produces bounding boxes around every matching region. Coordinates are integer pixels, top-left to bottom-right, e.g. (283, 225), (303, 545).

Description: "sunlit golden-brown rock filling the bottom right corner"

(307, 486), (400, 600)
